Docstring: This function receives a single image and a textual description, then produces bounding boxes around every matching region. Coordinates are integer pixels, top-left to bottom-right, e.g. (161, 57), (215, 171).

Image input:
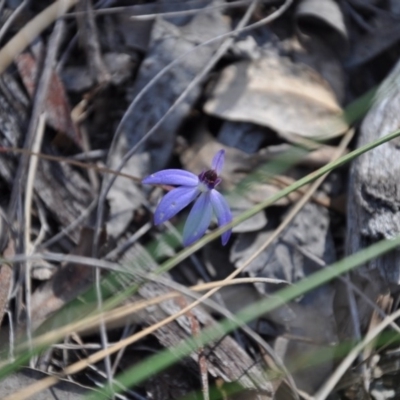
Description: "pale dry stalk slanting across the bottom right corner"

(313, 310), (400, 400)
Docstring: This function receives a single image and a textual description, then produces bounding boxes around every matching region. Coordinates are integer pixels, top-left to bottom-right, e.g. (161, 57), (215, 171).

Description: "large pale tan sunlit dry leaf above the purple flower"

(205, 55), (347, 141)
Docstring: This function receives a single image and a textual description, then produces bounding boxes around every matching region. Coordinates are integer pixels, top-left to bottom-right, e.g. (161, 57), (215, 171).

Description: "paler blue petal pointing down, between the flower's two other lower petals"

(183, 192), (212, 246)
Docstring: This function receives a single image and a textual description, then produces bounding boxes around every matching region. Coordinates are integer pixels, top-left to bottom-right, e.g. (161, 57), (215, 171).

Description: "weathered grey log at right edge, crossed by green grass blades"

(335, 59), (400, 339)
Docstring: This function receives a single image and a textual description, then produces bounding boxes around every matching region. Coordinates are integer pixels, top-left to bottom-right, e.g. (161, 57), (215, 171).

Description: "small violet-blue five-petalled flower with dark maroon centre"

(142, 150), (232, 246)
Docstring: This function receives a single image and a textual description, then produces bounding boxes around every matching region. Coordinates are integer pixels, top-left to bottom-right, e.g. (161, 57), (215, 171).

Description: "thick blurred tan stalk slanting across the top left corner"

(0, 0), (78, 74)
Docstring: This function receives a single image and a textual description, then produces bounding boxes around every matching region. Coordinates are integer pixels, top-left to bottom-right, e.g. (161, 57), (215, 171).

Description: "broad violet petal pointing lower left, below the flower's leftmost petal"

(154, 186), (200, 225)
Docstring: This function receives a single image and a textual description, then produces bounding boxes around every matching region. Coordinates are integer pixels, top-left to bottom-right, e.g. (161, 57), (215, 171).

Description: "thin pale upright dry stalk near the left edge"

(24, 113), (46, 368)
